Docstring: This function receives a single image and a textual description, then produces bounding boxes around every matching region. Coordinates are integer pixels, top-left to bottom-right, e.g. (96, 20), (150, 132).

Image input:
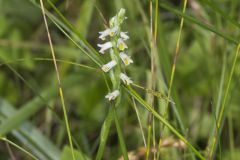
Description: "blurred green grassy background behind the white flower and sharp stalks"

(0, 0), (240, 160)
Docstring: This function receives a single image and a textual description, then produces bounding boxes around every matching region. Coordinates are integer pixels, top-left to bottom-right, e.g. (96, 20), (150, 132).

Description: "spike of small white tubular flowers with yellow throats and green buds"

(98, 9), (133, 101)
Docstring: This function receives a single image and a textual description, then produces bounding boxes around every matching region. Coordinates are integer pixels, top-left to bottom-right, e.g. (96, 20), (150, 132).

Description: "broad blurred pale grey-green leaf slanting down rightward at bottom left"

(0, 98), (60, 160)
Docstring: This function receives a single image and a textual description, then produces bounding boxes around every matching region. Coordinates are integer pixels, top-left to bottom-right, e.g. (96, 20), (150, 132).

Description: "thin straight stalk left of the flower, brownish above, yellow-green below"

(40, 0), (75, 160)
